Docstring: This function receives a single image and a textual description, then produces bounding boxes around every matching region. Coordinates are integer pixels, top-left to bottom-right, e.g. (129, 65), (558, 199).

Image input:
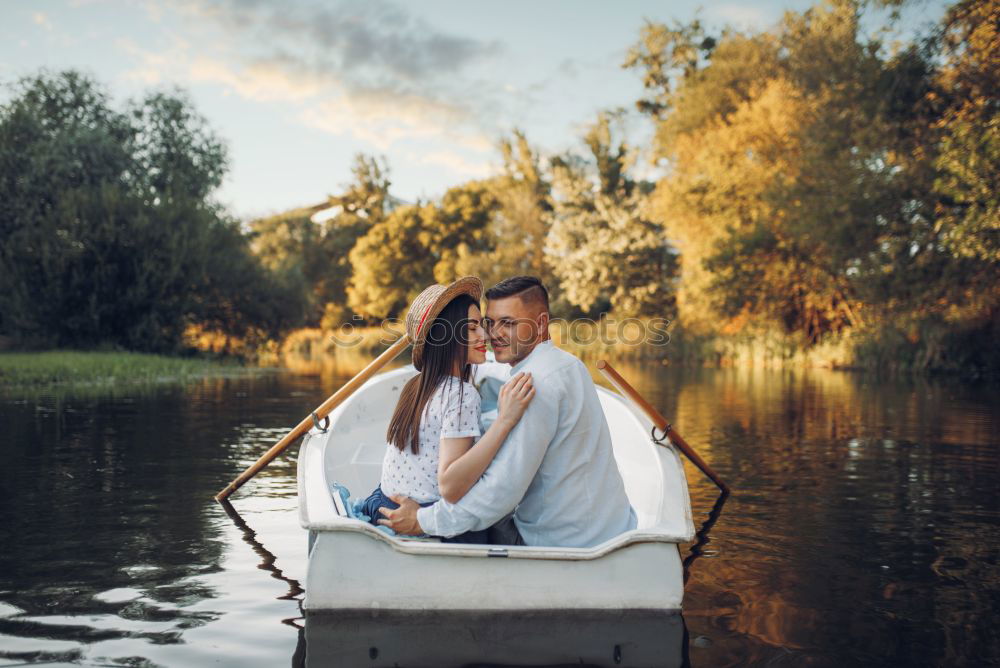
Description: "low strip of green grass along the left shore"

(0, 350), (254, 390)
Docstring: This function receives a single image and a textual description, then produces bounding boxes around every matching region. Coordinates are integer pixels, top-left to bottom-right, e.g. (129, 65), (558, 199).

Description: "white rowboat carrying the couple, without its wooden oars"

(298, 366), (695, 615)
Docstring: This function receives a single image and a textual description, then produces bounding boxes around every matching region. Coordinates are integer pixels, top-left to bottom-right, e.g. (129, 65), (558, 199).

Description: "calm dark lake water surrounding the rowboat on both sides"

(0, 364), (1000, 666)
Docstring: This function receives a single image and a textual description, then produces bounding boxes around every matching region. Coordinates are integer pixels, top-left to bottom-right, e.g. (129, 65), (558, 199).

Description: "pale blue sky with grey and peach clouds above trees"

(0, 0), (944, 218)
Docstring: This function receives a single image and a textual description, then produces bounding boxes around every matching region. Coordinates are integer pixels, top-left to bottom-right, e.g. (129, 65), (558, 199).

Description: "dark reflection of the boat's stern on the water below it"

(298, 610), (687, 668)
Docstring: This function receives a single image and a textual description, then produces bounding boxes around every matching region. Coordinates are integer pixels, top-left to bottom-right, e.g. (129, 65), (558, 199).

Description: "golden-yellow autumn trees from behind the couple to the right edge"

(240, 0), (1000, 369)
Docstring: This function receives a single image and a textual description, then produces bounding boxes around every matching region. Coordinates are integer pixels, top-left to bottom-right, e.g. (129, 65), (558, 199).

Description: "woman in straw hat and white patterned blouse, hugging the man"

(361, 276), (535, 543)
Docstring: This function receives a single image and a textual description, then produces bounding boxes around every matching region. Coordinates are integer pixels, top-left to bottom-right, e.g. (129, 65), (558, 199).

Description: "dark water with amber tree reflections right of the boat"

(632, 369), (1000, 665)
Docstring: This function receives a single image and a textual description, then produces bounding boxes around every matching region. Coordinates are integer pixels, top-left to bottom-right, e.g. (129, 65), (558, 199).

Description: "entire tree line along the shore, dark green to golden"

(0, 0), (1000, 383)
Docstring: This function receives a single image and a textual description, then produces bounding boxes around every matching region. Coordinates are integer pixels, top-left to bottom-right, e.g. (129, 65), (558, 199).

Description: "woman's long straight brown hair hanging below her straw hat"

(386, 295), (479, 454)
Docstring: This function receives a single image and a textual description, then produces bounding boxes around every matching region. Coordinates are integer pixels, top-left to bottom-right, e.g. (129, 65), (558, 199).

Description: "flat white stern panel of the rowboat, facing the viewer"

(305, 531), (684, 611)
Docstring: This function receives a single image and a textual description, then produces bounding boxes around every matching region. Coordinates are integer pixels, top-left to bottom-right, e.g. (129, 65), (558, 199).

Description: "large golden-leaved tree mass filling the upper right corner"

(625, 0), (1000, 365)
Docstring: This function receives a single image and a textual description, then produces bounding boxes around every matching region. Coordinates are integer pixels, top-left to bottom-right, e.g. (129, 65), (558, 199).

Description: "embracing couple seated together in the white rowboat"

(363, 276), (636, 547)
